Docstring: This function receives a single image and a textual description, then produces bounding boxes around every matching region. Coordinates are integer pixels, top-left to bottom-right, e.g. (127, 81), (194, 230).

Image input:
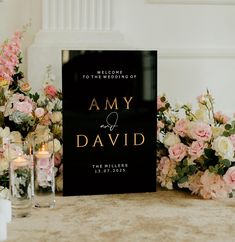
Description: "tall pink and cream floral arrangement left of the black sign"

(0, 30), (63, 196)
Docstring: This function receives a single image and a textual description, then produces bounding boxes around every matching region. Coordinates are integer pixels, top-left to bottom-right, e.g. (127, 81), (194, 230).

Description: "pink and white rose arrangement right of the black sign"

(157, 91), (235, 199)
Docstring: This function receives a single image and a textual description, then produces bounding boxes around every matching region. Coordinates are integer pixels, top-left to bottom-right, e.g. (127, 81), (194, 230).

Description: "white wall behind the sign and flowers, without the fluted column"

(0, 0), (235, 114)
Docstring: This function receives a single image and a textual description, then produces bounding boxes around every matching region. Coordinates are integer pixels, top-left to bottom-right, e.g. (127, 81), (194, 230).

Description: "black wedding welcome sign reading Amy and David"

(62, 50), (157, 196)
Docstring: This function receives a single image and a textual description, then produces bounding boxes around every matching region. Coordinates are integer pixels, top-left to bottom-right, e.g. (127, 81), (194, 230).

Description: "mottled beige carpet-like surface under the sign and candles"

(7, 191), (235, 242)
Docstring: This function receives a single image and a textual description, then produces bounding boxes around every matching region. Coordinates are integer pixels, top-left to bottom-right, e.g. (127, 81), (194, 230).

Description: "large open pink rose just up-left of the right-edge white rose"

(190, 122), (212, 141)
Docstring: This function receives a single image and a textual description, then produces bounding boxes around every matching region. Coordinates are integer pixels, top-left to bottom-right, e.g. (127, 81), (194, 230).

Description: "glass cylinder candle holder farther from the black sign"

(9, 142), (32, 217)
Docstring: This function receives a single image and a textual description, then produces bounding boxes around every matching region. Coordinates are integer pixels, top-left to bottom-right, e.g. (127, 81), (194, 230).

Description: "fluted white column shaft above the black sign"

(42, 0), (112, 31)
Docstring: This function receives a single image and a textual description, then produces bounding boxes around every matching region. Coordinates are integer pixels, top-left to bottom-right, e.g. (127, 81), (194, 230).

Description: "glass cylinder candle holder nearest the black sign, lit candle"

(33, 133), (55, 208)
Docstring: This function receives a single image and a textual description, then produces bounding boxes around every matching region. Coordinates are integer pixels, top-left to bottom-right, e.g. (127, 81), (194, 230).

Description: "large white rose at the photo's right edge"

(212, 136), (234, 160)
